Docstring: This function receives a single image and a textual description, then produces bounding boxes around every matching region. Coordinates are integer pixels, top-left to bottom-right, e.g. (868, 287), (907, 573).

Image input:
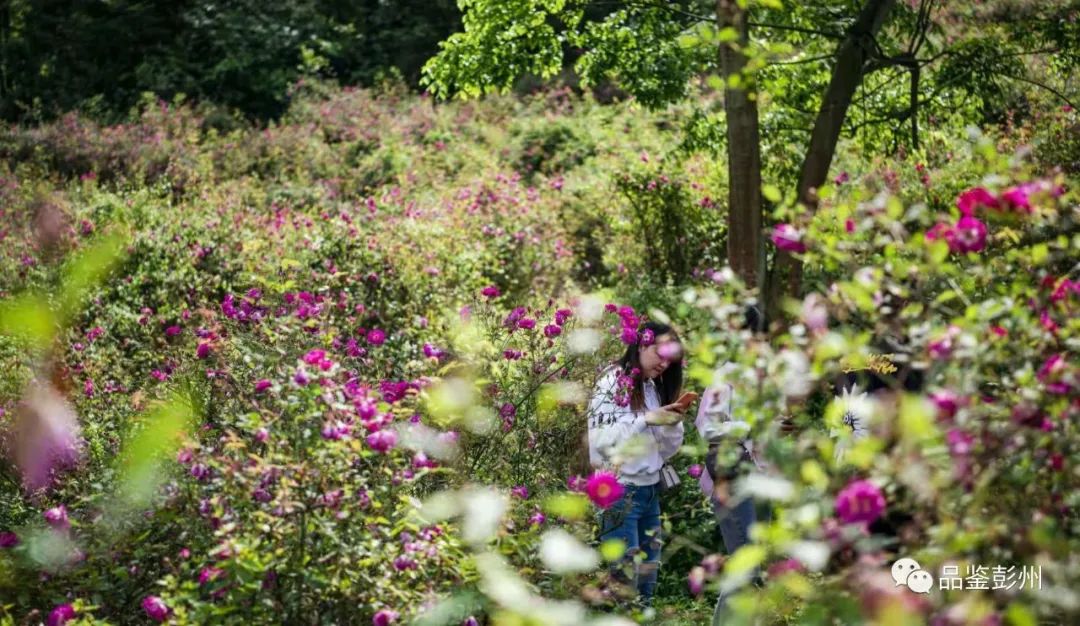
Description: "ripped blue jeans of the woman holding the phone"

(599, 485), (661, 605)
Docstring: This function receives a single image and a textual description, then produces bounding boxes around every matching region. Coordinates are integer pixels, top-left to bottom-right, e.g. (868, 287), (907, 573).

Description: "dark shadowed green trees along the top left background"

(0, 0), (459, 125)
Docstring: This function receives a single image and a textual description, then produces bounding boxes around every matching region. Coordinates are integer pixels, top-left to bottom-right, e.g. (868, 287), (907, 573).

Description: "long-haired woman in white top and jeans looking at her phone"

(589, 322), (692, 607)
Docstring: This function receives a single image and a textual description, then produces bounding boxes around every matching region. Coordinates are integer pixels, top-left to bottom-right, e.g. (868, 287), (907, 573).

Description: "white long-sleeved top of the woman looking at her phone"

(589, 367), (683, 486)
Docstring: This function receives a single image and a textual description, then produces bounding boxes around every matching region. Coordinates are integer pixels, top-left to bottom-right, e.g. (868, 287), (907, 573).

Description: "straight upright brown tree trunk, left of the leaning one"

(716, 0), (765, 287)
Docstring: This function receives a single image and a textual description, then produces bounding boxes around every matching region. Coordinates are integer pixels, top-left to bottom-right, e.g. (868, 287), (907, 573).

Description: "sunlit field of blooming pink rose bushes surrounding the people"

(0, 74), (1080, 626)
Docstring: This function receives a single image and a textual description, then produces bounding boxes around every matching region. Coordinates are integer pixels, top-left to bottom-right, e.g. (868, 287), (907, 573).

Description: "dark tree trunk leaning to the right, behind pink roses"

(767, 0), (895, 313)
